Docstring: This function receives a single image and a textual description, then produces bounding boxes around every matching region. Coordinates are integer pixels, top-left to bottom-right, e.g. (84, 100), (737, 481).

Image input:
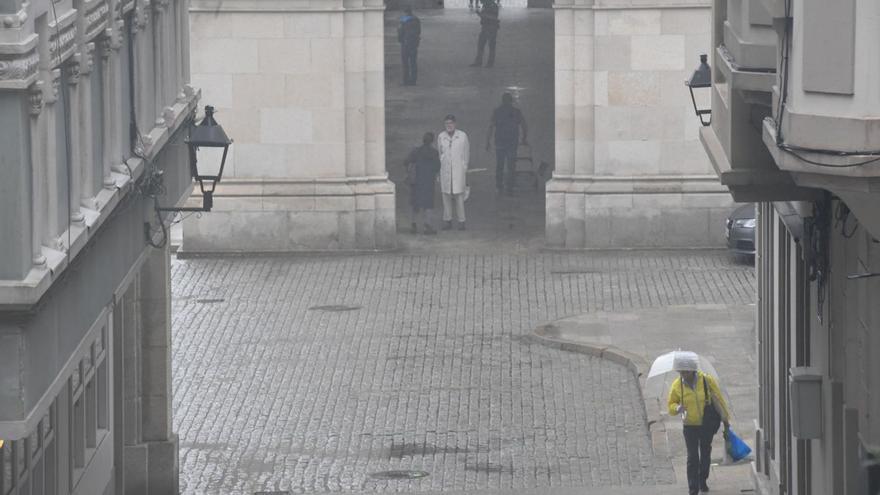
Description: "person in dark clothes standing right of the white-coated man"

(486, 93), (529, 194)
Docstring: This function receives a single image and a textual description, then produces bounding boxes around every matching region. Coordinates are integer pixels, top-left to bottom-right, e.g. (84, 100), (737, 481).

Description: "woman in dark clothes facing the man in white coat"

(405, 132), (440, 235)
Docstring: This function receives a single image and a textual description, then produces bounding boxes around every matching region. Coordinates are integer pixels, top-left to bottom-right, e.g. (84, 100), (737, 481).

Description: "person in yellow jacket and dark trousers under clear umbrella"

(668, 352), (730, 495)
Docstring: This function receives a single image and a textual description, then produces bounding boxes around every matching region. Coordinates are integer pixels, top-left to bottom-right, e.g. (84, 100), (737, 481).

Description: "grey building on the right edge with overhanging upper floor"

(700, 0), (880, 495)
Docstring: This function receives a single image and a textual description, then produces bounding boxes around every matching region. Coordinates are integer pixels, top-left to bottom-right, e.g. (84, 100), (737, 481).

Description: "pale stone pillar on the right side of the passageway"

(546, 0), (732, 248)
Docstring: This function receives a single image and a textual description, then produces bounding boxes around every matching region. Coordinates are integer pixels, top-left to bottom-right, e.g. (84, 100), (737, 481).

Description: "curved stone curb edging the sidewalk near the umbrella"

(526, 323), (672, 461)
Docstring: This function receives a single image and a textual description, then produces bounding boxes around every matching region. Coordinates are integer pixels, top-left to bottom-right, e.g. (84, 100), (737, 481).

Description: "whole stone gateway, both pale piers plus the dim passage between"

(183, 0), (731, 252)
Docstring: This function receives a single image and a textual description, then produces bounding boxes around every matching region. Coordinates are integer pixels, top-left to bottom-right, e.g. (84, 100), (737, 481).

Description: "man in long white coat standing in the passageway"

(437, 115), (471, 230)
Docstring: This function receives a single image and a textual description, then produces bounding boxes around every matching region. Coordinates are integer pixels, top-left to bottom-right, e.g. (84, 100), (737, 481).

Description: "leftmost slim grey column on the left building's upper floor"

(28, 81), (46, 266)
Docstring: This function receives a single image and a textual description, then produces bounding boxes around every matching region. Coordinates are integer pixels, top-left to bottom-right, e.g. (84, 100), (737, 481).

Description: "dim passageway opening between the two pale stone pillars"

(385, 6), (554, 249)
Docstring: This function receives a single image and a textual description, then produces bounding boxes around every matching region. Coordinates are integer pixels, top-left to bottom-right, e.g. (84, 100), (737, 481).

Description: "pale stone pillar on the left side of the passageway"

(187, 0), (396, 253)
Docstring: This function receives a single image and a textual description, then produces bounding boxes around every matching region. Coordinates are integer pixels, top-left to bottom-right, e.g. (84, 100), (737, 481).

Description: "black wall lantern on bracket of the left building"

(159, 105), (232, 211)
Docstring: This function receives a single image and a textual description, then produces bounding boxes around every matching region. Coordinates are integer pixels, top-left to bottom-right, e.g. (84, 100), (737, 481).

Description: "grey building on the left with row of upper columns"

(0, 0), (199, 495)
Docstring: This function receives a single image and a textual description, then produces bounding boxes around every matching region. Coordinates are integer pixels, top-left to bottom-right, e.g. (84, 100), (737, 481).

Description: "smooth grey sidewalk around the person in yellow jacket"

(534, 305), (757, 495)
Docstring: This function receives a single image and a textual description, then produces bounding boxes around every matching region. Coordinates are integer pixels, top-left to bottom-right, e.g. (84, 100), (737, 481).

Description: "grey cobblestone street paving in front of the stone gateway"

(172, 251), (754, 494)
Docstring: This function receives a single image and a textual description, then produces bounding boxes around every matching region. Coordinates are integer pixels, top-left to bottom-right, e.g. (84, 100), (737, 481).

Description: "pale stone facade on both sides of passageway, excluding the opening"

(183, 0), (732, 251)
